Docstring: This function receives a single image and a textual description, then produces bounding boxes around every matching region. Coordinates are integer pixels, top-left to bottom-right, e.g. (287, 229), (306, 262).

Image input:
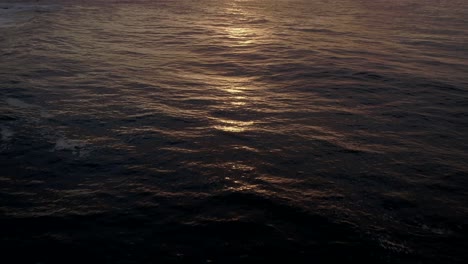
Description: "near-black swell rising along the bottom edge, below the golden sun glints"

(0, 193), (410, 263)
